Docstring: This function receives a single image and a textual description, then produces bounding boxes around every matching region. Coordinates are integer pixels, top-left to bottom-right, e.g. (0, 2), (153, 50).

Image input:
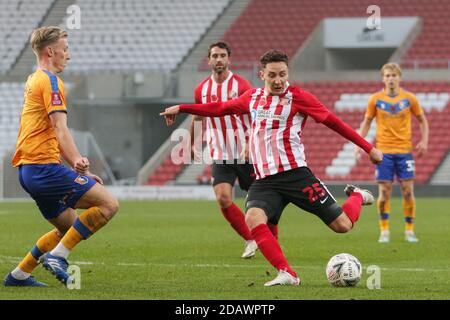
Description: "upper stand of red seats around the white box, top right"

(217, 0), (450, 69)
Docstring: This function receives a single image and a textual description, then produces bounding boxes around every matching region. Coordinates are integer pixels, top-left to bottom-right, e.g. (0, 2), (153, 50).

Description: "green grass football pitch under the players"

(0, 198), (450, 300)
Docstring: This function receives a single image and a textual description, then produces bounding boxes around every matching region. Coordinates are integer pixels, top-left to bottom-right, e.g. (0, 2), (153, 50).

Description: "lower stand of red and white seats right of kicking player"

(299, 81), (450, 183)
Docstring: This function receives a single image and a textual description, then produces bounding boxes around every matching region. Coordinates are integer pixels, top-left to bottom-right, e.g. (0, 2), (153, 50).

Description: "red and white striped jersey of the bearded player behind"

(195, 71), (252, 160)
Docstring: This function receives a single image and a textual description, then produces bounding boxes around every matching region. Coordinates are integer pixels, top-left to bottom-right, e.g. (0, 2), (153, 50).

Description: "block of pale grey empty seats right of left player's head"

(63, 0), (230, 74)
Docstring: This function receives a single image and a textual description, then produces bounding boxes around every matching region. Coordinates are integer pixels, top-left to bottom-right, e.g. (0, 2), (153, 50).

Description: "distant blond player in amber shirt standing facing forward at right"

(355, 63), (428, 243)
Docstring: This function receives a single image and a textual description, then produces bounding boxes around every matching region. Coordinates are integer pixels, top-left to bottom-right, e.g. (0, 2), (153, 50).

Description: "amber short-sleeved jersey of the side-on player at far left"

(12, 70), (67, 167)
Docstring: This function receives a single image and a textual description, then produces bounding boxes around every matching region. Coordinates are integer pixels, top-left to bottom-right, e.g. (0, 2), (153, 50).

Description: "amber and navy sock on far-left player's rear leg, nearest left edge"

(18, 229), (61, 273)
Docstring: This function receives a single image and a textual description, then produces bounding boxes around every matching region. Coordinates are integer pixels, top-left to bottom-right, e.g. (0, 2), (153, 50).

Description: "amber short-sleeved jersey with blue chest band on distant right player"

(366, 89), (423, 154)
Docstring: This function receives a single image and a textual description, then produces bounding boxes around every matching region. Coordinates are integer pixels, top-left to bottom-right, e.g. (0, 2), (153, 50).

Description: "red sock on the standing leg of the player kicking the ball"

(252, 223), (297, 277)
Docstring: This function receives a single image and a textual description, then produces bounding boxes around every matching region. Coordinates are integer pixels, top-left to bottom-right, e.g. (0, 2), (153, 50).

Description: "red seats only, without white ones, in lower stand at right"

(295, 81), (450, 183)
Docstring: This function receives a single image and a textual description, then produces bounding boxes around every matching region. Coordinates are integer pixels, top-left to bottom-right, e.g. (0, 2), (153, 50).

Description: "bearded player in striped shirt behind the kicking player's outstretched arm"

(190, 42), (258, 258)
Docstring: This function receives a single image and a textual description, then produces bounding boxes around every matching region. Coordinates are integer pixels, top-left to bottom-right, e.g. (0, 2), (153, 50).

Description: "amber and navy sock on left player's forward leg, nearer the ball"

(61, 207), (108, 250)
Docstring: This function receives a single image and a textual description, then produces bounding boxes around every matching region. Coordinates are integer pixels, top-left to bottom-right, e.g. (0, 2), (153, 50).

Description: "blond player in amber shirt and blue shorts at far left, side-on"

(4, 27), (119, 286)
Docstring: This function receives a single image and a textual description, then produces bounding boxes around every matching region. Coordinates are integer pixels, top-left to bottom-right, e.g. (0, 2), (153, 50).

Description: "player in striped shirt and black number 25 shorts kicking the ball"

(160, 50), (383, 286)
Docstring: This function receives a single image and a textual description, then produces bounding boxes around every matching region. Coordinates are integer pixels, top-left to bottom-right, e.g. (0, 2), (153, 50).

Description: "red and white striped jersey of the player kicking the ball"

(180, 85), (331, 179)
